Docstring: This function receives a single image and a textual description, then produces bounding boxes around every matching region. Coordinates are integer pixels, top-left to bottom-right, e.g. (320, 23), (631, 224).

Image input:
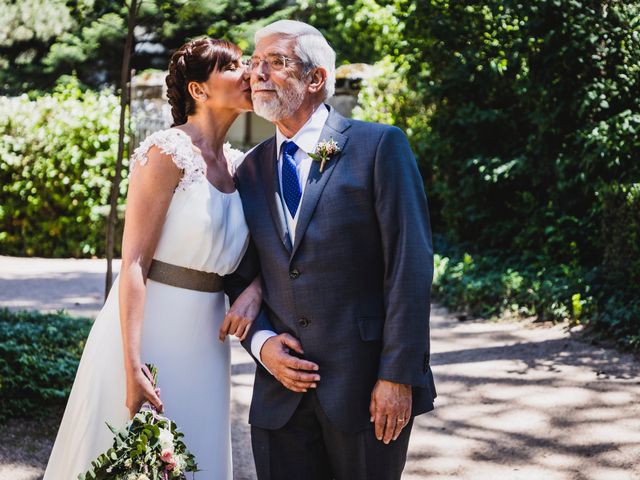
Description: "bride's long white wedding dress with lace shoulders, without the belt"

(44, 129), (249, 480)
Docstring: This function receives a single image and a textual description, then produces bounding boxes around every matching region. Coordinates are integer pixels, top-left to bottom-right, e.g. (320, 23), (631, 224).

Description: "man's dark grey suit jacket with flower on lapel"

(230, 109), (436, 431)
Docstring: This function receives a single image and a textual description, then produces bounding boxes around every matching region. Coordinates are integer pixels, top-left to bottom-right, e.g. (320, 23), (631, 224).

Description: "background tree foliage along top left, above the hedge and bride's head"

(0, 0), (296, 95)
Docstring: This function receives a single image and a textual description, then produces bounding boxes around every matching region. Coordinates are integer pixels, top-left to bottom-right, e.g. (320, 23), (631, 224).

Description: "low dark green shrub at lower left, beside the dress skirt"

(0, 309), (91, 419)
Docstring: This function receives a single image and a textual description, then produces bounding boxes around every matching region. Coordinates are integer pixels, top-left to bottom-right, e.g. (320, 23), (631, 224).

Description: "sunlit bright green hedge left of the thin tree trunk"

(0, 78), (127, 257)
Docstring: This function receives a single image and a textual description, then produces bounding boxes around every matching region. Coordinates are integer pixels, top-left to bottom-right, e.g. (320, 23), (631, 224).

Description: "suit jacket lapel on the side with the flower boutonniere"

(292, 107), (350, 257)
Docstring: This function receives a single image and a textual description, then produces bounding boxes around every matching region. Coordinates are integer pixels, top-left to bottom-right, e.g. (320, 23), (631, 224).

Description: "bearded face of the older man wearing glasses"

(250, 35), (307, 122)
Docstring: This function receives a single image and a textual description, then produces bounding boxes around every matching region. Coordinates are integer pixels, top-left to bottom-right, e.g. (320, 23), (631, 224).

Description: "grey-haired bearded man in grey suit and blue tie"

(236, 20), (436, 480)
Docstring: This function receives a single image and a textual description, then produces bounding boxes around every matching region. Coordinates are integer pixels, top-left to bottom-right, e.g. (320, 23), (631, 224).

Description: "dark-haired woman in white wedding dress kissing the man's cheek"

(44, 39), (262, 480)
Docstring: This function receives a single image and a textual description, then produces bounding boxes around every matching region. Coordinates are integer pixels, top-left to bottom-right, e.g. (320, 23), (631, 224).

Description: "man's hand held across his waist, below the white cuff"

(260, 333), (320, 393)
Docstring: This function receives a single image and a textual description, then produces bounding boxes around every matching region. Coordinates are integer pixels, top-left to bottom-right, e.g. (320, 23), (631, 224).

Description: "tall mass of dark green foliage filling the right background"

(310, 0), (640, 344)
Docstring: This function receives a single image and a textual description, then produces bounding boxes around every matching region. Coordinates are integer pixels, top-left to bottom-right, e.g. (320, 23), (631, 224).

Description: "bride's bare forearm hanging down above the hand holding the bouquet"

(119, 261), (146, 373)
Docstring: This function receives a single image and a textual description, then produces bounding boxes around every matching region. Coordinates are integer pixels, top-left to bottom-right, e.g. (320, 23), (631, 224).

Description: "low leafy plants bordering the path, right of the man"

(433, 246), (640, 351)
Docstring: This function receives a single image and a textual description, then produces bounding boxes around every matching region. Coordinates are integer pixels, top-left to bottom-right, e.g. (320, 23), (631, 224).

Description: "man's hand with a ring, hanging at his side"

(369, 380), (411, 445)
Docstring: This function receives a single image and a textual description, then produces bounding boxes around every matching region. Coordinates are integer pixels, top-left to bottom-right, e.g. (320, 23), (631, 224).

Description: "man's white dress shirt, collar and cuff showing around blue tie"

(251, 104), (329, 371)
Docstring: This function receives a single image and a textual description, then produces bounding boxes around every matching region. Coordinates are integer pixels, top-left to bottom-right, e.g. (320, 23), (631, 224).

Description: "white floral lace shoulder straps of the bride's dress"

(129, 128), (244, 191)
